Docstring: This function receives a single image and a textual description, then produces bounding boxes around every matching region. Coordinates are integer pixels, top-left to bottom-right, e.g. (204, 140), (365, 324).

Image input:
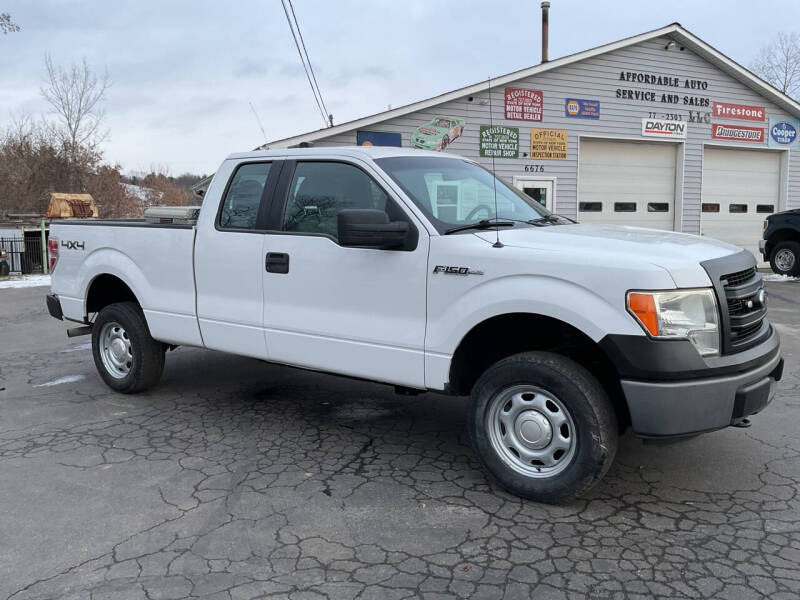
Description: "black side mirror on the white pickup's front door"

(338, 208), (408, 250)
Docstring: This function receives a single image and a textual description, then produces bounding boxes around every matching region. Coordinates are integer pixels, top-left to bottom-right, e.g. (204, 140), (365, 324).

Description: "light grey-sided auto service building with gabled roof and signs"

(265, 23), (800, 258)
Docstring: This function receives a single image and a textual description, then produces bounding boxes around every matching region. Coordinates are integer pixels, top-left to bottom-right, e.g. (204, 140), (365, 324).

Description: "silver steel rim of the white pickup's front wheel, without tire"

(486, 385), (577, 478)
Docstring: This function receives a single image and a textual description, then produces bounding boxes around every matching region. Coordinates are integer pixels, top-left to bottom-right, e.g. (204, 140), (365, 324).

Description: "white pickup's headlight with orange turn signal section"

(628, 289), (719, 356)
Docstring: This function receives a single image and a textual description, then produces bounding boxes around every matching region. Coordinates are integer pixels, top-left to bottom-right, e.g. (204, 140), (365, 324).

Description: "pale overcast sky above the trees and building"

(0, 0), (800, 175)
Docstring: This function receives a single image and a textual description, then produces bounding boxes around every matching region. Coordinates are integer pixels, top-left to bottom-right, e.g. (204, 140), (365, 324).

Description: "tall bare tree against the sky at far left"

(40, 54), (109, 173)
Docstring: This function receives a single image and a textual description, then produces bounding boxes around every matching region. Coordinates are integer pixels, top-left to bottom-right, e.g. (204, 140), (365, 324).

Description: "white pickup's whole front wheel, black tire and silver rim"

(469, 352), (618, 504)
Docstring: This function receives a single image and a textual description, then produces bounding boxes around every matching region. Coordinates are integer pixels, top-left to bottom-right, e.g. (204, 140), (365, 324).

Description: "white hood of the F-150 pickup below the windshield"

(475, 224), (741, 287)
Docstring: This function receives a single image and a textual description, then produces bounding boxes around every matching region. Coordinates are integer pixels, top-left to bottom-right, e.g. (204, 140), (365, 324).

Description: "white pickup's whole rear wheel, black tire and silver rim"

(92, 302), (165, 394)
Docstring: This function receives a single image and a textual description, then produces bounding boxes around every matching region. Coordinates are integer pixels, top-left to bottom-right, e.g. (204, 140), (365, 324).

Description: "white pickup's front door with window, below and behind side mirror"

(261, 159), (428, 388)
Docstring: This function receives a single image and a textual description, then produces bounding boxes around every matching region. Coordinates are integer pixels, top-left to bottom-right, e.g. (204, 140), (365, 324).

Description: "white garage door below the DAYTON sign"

(578, 138), (677, 229)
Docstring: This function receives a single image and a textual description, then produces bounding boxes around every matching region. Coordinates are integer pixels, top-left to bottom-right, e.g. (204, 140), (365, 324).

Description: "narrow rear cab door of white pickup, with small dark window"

(194, 159), (282, 359)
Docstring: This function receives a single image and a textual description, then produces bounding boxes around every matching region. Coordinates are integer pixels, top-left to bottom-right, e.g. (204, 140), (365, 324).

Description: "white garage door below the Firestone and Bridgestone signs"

(700, 148), (781, 262)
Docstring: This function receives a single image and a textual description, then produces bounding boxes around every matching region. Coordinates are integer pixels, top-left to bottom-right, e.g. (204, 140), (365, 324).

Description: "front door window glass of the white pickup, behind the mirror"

(283, 162), (392, 239)
